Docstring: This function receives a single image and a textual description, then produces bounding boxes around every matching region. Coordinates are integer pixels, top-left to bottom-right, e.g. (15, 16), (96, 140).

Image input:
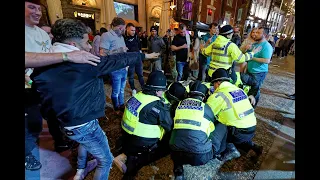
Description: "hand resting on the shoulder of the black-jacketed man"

(67, 51), (100, 66)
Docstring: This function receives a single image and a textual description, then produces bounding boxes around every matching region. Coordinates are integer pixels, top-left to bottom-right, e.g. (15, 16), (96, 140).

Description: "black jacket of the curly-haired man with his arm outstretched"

(31, 52), (145, 127)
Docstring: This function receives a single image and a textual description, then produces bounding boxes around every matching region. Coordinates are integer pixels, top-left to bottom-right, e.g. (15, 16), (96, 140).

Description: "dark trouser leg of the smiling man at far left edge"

(24, 104), (42, 156)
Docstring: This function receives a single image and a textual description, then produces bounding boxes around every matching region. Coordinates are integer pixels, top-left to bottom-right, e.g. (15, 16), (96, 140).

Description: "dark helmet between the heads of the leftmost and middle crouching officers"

(165, 82), (187, 101)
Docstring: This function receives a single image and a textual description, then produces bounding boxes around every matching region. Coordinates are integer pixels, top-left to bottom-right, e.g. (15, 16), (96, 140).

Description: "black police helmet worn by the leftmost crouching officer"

(144, 71), (167, 91)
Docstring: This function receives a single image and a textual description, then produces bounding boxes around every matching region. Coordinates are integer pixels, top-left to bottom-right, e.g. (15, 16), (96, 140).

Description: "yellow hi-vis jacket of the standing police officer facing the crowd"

(201, 35), (254, 77)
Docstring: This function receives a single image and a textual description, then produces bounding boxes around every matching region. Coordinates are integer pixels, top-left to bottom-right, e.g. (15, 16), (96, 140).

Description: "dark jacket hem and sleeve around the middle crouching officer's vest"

(170, 97), (215, 154)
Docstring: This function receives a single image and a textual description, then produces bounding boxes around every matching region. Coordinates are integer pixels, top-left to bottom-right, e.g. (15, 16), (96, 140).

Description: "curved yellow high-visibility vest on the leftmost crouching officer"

(121, 92), (165, 140)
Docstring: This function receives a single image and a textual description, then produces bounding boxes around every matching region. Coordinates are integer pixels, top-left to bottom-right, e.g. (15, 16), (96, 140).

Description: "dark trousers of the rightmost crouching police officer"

(227, 126), (256, 152)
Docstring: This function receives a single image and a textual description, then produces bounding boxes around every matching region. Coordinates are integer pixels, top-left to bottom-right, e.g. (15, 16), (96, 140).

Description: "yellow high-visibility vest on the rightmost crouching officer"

(208, 82), (257, 128)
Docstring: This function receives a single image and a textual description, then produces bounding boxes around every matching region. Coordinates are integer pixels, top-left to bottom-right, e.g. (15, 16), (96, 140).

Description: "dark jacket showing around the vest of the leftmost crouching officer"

(123, 92), (173, 154)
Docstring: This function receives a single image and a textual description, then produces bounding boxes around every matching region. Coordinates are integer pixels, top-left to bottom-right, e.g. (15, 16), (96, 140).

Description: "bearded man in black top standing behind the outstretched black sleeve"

(123, 23), (144, 96)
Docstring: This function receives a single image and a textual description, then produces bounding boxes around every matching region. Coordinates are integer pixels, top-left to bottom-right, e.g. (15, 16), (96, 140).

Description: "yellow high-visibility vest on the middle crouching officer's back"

(173, 98), (215, 137)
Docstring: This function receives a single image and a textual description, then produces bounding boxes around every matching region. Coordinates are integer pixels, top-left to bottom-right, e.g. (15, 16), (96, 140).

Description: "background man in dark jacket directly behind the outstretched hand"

(148, 26), (166, 71)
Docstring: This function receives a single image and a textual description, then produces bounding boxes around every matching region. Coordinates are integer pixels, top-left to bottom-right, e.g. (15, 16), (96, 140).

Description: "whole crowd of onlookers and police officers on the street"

(25, 0), (294, 180)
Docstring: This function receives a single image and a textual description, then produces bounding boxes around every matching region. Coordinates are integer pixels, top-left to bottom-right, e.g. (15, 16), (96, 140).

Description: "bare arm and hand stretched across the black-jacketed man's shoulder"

(25, 51), (100, 68)
